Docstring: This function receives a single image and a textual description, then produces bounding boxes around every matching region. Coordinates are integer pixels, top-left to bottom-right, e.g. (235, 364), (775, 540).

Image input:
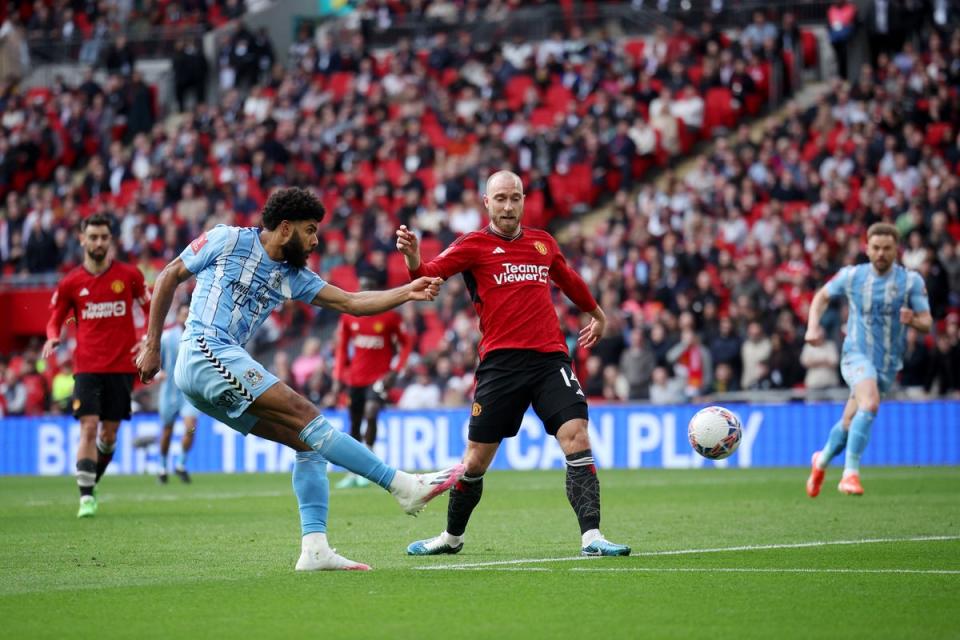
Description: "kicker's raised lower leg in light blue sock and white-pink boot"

(300, 415), (464, 515)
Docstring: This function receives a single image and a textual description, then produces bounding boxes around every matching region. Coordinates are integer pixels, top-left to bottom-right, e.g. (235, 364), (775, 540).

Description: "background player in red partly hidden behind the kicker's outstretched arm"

(333, 275), (413, 489)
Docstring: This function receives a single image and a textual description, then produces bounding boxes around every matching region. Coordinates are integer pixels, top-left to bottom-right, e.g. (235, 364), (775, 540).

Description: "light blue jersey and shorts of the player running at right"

(826, 264), (930, 391)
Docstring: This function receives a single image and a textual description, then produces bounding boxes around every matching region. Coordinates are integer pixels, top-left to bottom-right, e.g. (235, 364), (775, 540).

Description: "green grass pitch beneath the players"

(0, 467), (960, 639)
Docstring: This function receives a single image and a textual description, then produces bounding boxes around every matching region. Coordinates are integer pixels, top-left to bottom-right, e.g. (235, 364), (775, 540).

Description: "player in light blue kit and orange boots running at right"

(805, 222), (933, 498)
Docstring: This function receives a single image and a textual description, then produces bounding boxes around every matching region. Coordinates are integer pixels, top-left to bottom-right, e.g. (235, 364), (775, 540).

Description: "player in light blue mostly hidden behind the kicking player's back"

(157, 304), (197, 484)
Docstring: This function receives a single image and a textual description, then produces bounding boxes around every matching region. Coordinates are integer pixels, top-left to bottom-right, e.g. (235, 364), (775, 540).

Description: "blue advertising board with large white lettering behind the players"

(0, 401), (960, 475)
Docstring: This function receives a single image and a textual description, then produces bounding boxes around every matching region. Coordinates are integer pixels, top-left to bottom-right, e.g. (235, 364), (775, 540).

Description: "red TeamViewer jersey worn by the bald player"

(410, 226), (597, 360)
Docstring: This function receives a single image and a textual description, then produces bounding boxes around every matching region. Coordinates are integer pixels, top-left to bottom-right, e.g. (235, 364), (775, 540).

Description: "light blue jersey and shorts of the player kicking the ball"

(174, 225), (326, 434)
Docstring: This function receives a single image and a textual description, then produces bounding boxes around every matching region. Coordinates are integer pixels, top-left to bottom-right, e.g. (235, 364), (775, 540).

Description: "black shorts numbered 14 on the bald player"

(469, 349), (587, 443)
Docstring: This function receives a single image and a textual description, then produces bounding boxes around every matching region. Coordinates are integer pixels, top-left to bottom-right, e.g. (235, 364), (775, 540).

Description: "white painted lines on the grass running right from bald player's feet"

(413, 535), (960, 575)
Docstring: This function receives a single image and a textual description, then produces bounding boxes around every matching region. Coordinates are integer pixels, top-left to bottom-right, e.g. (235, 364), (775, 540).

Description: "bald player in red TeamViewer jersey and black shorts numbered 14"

(397, 171), (630, 556)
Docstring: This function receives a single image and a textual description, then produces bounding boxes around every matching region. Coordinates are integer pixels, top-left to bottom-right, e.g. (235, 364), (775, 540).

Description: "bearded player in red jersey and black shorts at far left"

(43, 214), (150, 518)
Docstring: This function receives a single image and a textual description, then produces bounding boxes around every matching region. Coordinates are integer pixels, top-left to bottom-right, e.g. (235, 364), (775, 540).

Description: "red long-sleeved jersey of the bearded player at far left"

(47, 260), (150, 373)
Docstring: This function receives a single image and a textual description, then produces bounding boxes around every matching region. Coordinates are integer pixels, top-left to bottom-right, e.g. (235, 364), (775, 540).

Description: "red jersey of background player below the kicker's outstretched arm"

(333, 311), (413, 387)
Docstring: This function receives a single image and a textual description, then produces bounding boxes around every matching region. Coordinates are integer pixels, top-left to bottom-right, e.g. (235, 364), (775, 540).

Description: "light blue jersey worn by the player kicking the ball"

(180, 225), (326, 346)
